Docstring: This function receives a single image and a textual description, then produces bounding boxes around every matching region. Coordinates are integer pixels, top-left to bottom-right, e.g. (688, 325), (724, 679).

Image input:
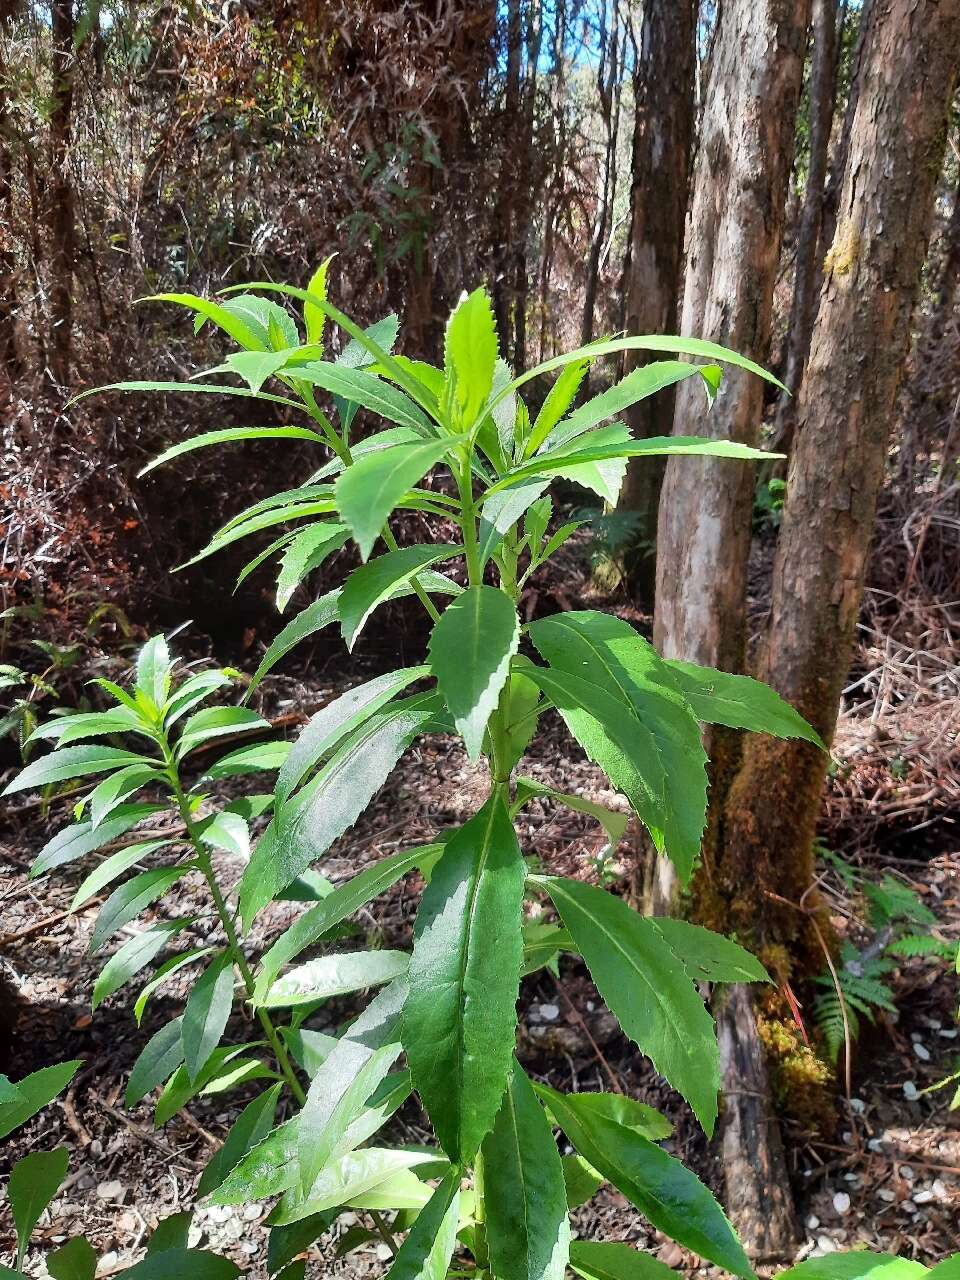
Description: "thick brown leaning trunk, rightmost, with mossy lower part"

(722, 0), (960, 988)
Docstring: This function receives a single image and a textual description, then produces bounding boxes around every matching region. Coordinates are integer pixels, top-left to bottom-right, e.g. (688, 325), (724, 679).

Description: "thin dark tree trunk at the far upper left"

(50, 0), (76, 389)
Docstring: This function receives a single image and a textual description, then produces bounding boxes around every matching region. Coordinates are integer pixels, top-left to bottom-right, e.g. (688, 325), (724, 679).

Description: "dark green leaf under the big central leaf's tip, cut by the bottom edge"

(483, 1064), (570, 1280)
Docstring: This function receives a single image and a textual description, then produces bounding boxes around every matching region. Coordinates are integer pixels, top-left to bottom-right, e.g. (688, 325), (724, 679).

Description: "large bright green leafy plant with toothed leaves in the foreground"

(8, 275), (839, 1280)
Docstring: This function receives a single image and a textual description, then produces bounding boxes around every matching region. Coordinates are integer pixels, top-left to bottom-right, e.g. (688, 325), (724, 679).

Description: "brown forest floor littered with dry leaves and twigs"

(0, 547), (960, 1280)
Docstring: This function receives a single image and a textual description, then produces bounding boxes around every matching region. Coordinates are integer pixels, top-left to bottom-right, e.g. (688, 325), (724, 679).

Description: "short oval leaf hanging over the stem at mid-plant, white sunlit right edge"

(430, 585), (520, 760)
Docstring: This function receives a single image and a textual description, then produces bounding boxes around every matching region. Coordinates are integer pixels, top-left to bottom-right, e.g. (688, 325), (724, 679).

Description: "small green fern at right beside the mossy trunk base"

(814, 845), (955, 1060)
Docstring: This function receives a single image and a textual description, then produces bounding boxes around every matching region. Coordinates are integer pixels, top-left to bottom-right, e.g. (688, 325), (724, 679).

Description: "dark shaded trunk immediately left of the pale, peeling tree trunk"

(620, 0), (696, 607)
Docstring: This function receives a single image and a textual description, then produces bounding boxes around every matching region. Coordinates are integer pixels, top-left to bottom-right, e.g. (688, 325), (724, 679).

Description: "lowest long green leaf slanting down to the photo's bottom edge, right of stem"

(536, 1085), (753, 1280)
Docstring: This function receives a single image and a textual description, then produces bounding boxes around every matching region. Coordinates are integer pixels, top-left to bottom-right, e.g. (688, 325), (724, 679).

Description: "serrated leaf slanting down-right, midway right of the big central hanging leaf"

(543, 877), (719, 1136)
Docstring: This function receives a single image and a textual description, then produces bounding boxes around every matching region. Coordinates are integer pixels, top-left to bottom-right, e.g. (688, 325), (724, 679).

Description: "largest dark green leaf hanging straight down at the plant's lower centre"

(403, 794), (526, 1162)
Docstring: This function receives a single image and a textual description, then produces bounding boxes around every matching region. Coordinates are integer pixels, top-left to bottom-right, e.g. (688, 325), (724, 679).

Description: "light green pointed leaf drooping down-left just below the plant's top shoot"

(335, 438), (458, 559)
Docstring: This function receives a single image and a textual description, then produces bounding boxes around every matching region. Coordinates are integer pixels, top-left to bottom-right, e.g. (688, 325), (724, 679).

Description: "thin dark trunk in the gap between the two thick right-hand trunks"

(773, 0), (837, 474)
